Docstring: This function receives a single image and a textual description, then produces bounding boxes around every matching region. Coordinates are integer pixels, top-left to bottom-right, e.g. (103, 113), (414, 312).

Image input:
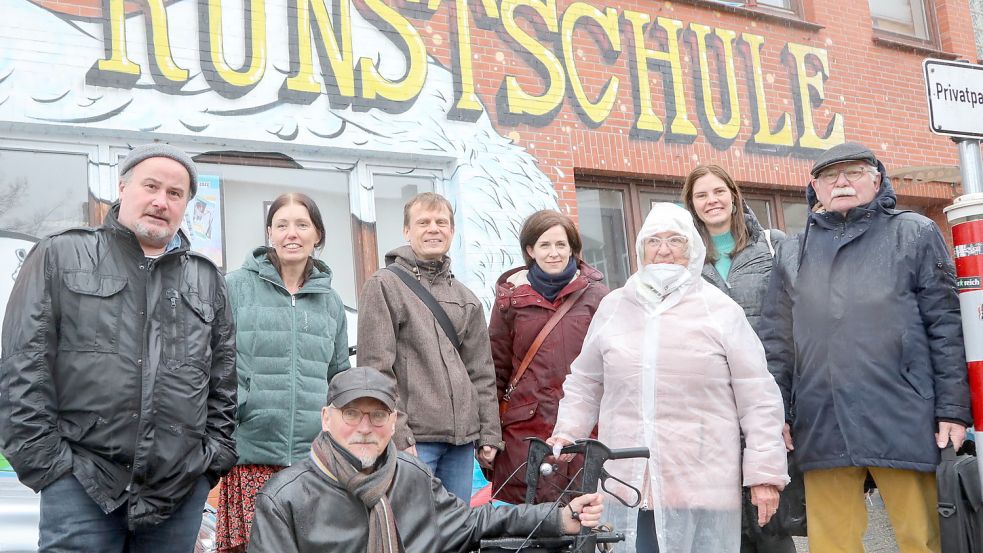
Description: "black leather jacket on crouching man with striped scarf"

(249, 452), (561, 553)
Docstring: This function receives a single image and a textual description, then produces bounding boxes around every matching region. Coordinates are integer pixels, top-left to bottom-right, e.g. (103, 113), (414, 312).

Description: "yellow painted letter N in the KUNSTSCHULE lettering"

(280, 0), (355, 103)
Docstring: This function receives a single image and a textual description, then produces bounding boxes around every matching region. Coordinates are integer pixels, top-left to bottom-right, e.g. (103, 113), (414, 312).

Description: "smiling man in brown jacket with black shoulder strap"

(358, 192), (503, 501)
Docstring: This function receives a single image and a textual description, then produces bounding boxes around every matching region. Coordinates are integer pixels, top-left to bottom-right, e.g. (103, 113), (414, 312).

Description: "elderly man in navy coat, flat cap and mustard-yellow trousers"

(761, 143), (971, 553)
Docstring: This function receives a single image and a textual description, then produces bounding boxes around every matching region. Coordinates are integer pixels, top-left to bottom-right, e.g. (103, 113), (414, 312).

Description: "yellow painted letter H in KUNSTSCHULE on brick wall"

(622, 10), (696, 142)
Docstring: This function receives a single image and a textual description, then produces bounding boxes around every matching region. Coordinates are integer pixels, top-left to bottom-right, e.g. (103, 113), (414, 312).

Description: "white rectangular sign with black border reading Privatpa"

(922, 59), (983, 139)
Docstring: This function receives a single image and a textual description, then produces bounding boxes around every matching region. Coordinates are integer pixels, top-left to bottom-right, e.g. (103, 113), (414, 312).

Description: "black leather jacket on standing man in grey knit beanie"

(0, 205), (236, 527)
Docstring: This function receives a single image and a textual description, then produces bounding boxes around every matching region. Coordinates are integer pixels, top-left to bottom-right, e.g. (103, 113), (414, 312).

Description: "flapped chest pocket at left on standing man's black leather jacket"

(58, 270), (127, 353)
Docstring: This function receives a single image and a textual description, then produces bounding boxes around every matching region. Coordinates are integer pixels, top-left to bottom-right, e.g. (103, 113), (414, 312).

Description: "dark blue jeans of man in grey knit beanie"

(38, 474), (209, 553)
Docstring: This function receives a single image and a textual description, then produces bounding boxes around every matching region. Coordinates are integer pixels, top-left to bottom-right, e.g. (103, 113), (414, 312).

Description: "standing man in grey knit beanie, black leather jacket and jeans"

(0, 144), (236, 553)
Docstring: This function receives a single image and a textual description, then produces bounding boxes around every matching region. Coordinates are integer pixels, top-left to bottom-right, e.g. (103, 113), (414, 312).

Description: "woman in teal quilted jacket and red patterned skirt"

(216, 193), (349, 551)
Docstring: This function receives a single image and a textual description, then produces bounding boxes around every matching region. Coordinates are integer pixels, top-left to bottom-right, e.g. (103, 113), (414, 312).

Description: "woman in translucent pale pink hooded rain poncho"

(549, 203), (788, 553)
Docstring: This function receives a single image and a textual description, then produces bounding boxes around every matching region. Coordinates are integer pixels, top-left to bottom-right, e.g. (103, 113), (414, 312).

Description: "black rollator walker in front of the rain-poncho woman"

(478, 438), (649, 553)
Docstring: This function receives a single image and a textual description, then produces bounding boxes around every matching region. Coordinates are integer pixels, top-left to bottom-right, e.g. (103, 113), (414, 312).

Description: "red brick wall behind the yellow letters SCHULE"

(392, 0), (981, 230)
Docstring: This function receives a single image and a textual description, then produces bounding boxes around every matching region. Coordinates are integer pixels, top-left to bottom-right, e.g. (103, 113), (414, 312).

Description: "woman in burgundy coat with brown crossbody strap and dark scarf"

(489, 210), (609, 503)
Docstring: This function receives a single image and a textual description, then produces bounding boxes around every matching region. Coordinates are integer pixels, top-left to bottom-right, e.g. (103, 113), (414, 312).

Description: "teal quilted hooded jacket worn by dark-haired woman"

(226, 247), (349, 466)
